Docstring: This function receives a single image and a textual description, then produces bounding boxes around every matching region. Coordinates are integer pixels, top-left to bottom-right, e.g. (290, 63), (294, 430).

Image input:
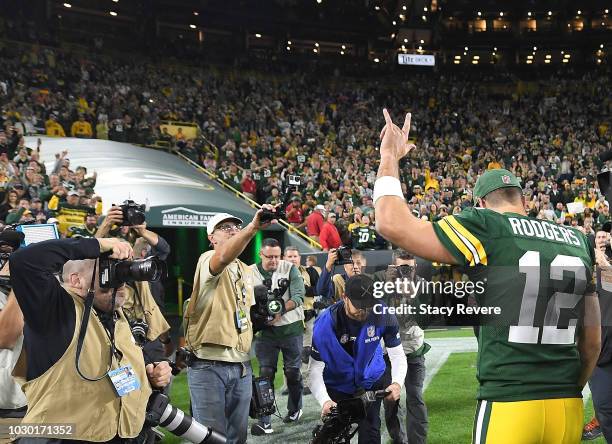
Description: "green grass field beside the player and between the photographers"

(164, 329), (605, 444)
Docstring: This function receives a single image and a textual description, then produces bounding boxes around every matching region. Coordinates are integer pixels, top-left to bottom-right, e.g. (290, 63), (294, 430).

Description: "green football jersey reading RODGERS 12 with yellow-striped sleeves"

(434, 208), (595, 401)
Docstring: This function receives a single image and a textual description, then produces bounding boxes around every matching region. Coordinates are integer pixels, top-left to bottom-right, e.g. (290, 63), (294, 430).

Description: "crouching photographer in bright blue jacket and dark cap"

(310, 275), (406, 444)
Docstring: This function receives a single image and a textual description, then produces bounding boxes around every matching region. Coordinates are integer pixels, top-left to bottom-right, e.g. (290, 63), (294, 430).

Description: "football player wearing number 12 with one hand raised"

(374, 110), (600, 444)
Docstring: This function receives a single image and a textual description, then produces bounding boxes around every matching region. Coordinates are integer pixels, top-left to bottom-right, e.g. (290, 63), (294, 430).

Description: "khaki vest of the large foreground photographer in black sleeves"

(23, 294), (151, 442)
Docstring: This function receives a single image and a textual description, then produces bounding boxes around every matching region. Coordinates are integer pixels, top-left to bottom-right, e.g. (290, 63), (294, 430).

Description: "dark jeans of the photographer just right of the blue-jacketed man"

(383, 356), (428, 444)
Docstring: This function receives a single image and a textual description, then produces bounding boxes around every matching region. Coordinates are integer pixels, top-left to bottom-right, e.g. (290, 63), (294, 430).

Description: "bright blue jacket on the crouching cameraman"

(313, 301), (386, 394)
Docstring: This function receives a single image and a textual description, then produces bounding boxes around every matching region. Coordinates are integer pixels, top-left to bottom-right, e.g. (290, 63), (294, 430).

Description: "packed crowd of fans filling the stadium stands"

(0, 40), (612, 248)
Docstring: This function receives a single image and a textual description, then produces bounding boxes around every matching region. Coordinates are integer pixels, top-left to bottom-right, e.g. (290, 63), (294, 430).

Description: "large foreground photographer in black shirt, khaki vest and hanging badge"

(10, 239), (170, 443)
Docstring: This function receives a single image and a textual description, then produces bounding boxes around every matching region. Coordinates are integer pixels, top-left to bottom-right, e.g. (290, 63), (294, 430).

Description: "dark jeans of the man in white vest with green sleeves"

(255, 335), (304, 424)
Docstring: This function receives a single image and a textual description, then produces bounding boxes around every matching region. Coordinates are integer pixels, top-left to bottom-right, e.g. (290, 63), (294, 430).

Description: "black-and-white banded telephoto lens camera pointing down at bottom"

(145, 391), (226, 444)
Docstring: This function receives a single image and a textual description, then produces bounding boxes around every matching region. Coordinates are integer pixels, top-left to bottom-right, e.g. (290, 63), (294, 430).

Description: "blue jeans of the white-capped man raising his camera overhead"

(187, 361), (253, 444)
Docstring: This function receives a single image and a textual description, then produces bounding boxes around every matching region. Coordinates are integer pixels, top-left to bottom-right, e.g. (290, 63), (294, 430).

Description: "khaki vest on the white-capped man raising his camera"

(185, 255), (253, 353)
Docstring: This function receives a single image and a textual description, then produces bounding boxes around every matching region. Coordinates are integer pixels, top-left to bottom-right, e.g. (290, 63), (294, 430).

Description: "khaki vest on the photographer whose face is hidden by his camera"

(123, 282), (170, 341)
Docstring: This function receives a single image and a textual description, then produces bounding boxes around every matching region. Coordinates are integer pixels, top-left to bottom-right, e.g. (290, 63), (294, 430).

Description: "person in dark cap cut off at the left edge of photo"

(0, 229), (26, 422)
